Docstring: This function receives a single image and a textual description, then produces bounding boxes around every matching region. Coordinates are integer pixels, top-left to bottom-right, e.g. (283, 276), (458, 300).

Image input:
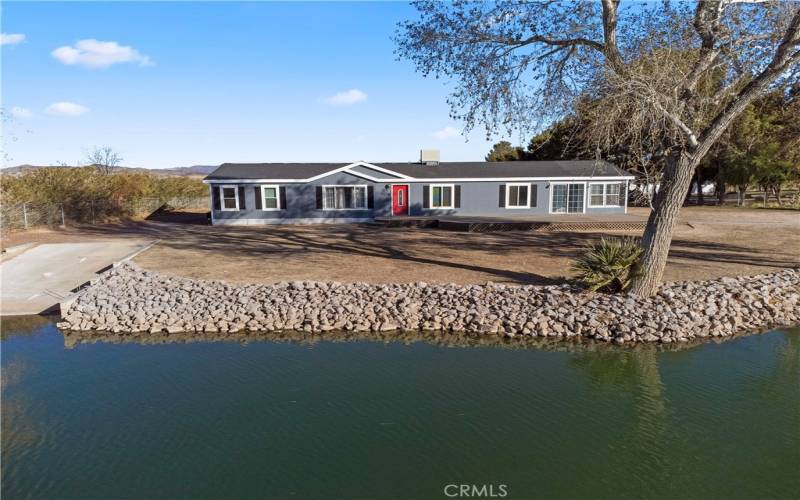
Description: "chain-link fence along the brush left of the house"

(0, 197), (208, 234)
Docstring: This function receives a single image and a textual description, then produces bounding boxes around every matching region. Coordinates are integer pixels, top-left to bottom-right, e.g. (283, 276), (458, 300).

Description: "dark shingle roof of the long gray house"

(206, 160), (630, 181)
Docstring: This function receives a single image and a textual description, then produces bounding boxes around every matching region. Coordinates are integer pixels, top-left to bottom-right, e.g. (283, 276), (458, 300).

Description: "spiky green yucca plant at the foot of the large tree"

(572, 238), (642, 292)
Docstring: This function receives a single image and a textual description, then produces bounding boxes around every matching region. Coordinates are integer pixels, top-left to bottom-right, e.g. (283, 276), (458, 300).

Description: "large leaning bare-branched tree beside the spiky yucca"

(396, 0), (800, 296)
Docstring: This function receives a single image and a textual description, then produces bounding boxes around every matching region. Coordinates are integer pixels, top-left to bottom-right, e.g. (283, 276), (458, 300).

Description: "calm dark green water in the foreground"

(2, 323), (800, 500)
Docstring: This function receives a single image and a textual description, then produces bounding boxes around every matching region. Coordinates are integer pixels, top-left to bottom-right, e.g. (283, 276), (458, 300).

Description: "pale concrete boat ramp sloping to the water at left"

(0, 240), (157, 316)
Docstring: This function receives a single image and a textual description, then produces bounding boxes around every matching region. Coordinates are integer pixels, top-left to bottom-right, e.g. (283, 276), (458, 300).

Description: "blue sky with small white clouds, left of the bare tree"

(2, 2), (506, 168)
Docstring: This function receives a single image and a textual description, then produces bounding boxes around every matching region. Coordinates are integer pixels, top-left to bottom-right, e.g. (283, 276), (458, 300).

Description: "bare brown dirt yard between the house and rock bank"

(5, 207), (800, 284)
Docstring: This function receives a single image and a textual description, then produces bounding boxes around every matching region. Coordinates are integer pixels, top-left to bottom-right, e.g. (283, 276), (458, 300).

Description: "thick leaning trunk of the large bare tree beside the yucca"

(631, 153), (699, 297)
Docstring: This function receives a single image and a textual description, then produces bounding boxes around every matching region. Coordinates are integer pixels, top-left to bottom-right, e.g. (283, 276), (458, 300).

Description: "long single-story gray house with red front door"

(203, 152), (633, 224)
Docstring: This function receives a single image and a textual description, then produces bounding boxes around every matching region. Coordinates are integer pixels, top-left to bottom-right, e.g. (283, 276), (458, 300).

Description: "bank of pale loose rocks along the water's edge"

(58, 263), (800, 343)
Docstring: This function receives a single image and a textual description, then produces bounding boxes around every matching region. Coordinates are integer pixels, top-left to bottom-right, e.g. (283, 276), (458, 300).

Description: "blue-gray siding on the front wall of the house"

(212, 172), (625, 223)
